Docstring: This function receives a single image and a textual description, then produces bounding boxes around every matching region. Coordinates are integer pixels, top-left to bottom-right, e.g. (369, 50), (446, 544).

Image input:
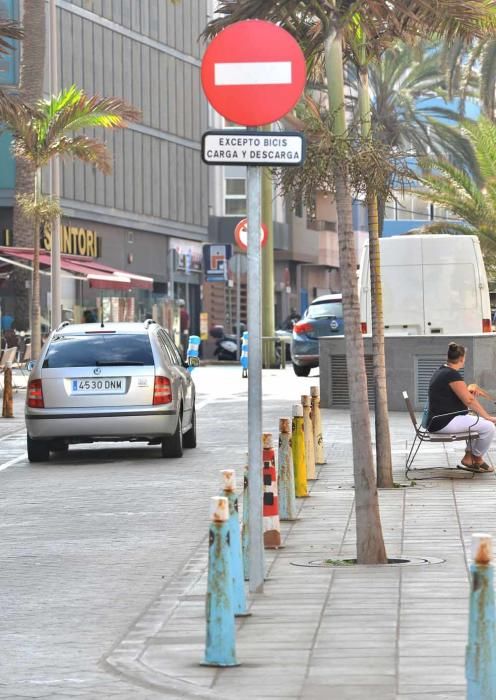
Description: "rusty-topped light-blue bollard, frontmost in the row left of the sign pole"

(203, 497), (239, 666)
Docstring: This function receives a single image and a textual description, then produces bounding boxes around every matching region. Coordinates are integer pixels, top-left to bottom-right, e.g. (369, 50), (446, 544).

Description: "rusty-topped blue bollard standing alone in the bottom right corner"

(465, 534), (496, 700)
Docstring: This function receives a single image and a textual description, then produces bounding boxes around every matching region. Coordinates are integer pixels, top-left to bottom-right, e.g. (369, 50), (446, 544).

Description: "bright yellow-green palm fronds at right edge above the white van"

(415, 117), (496, 250)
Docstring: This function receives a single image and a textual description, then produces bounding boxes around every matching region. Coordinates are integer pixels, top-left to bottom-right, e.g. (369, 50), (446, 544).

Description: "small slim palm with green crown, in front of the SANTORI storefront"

(0, 86), (139, 358)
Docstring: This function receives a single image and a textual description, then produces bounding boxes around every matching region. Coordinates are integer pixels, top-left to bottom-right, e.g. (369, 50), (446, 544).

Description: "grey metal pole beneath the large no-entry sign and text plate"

(247, 165), (265, 593)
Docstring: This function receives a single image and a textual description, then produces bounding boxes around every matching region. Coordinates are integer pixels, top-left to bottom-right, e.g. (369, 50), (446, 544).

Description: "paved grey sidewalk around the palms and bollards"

(106, 411), (496, 700)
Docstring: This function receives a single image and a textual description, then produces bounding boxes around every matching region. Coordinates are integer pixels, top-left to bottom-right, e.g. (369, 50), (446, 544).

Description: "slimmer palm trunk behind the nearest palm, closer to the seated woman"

(358, 61), (394, 488)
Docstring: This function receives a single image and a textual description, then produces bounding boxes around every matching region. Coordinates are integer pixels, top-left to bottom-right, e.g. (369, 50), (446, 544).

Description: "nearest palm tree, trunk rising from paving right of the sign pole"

(206, 0), (496, 564)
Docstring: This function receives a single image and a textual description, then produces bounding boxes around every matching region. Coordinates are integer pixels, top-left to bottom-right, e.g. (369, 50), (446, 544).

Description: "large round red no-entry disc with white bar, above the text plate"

(201, 19), (306, 126)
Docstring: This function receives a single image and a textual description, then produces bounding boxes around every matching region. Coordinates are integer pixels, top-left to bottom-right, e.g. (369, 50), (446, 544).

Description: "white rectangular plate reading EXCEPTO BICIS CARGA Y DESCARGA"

(202, 129), (305, 166)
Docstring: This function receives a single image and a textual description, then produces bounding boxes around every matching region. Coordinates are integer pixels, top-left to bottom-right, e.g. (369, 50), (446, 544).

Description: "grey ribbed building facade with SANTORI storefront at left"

(0, 0), (209, 330)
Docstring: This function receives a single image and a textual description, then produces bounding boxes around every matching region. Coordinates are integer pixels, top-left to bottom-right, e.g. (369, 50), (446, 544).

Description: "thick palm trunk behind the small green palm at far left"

(13, 0), (46, 329)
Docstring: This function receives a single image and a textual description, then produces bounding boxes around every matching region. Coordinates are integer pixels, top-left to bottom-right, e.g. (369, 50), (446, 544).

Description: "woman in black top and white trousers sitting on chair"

(427, 343), (496, 473)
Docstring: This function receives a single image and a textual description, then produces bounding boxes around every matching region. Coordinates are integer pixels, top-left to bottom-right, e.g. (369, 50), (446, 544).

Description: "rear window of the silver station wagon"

(43, 333), (154, 368)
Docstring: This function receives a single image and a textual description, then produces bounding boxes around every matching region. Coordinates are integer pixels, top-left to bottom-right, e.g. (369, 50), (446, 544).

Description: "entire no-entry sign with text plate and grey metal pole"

(201, 20), (306, 593)
